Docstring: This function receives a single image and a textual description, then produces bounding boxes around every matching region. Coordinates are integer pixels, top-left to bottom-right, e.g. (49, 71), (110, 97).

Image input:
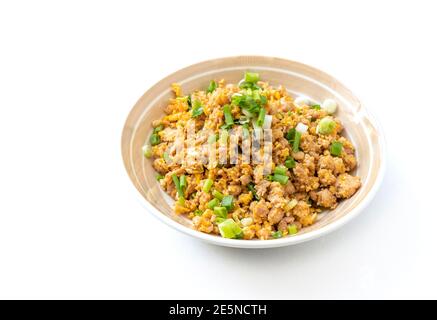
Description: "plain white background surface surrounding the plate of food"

(0, 0), (437, 299)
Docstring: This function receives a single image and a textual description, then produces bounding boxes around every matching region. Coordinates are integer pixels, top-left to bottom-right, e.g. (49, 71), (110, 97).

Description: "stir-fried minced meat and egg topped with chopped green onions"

(142, 72), (361, 240)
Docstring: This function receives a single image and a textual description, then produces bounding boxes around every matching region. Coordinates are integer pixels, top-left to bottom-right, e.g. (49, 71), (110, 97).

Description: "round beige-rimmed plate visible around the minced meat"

(121, 56), (385, 248)
